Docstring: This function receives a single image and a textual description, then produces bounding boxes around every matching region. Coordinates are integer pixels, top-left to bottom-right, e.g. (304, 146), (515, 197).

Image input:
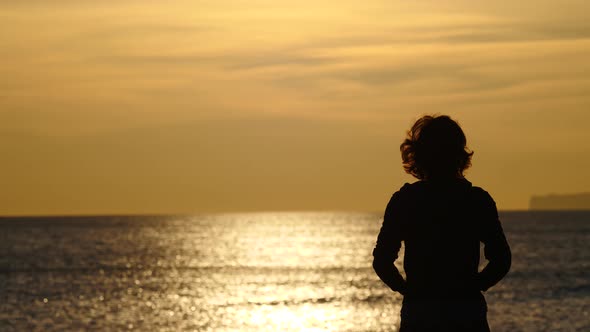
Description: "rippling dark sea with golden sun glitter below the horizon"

(0, 211), (590, 332)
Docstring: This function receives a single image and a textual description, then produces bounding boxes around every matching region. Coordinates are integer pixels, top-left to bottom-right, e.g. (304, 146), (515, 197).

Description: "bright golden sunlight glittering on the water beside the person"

(186, 213), (399, 331)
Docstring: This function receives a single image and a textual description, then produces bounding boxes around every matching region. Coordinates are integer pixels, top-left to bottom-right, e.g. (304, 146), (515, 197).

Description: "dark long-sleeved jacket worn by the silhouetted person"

(373, 179), (511, 320)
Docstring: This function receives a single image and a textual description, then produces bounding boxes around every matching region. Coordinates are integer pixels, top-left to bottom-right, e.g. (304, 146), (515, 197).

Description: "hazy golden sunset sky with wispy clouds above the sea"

(0, 0), (590, 215)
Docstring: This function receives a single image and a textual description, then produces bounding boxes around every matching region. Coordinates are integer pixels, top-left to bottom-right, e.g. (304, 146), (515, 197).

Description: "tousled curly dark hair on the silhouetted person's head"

(400, 115), (473, 180)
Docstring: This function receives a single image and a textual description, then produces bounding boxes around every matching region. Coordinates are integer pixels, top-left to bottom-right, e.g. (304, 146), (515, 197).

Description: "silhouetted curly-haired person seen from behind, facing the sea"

(373, 116), (511, 332)
